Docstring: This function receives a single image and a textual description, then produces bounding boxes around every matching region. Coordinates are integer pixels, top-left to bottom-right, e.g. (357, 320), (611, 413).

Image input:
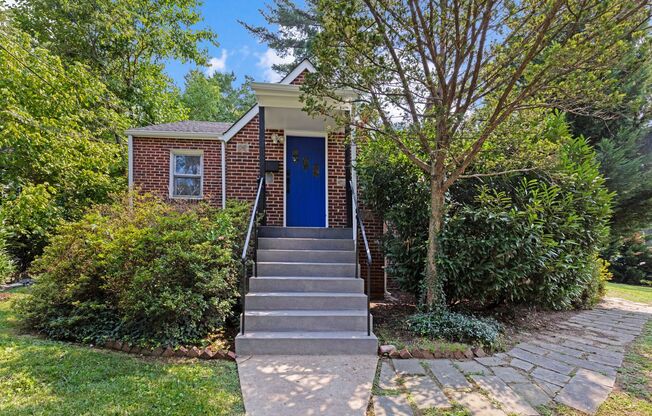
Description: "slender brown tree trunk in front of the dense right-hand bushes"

(426, 174), (446, 311)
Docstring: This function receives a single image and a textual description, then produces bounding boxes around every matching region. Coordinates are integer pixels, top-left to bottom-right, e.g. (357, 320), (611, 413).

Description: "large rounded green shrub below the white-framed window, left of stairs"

(19, 195), (246, 346)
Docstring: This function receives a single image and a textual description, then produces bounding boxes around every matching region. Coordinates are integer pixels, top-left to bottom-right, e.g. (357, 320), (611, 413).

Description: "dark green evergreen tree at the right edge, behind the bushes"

(571, 33), (652, 239)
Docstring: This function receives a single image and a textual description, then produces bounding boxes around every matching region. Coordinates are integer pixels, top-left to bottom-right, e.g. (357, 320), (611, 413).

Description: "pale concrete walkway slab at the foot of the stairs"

(237, 355), (378, 416)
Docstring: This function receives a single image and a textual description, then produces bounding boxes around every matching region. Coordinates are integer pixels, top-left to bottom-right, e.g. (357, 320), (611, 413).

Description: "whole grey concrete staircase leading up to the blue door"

(235, 227), (378, 356)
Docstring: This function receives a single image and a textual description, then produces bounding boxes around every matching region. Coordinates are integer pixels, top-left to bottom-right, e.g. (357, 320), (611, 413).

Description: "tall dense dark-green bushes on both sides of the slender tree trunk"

(358, 129), (611, 309)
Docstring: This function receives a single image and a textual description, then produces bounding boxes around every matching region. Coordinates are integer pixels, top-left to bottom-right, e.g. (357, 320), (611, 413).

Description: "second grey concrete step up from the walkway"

(245, 309), (367, 332)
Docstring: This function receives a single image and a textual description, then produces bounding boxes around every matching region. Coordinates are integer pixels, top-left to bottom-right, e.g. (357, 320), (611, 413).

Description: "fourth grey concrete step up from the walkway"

(249, 276), (364, 293)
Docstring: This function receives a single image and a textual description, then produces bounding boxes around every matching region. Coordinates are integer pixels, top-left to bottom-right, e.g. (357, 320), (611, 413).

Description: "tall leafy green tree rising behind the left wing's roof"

(13, 0), (217, 125)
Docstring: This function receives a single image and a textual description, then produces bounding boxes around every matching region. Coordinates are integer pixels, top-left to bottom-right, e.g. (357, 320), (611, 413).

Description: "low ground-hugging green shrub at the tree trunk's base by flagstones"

(407, 311), (503, 349)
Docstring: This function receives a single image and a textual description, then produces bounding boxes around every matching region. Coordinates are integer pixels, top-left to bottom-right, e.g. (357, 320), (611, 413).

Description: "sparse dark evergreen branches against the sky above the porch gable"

(240, 0), (320, 74)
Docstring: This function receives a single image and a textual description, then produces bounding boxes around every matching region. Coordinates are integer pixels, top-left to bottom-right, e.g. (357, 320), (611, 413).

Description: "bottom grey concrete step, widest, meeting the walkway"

(235, 331), (378, 356)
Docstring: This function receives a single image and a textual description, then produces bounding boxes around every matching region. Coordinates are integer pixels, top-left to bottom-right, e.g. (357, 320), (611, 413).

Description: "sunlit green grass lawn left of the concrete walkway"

(0, 294), (244, 416)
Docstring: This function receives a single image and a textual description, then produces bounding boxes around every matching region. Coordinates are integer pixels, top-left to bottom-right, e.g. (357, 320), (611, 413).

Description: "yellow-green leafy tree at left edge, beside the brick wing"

(0, 20), (129, 269)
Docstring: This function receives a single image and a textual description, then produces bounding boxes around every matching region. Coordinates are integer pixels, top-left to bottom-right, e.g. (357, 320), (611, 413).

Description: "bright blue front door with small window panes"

(285, 137), (326, 227)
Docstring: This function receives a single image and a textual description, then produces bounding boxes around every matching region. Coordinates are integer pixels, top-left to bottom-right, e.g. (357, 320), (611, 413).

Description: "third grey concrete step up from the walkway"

(246, 292), (367, 312)
